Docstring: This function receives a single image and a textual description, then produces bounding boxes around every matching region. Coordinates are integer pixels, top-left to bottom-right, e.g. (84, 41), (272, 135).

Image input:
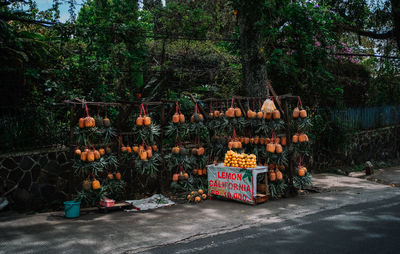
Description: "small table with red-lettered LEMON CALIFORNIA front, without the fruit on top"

(207, 163), (268, 205)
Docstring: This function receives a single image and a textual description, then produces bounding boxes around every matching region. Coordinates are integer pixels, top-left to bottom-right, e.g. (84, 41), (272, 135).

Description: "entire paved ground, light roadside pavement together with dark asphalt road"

(0, 174), (400, 254)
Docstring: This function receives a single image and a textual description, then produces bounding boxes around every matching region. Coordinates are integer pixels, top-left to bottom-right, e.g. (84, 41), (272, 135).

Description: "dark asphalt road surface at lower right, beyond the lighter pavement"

(140, 196), (400, 254)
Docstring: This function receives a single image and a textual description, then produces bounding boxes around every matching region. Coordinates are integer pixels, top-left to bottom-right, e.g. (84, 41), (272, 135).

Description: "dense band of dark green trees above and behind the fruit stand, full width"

(0, 0), (400, 105)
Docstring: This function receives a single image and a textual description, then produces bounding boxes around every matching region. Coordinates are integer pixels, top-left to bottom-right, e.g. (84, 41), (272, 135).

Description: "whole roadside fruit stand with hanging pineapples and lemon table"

(66, 86), (311, 205)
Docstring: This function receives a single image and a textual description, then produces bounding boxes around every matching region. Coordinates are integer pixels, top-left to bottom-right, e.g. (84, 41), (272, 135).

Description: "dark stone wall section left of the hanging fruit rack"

(0, 148), (73, 211)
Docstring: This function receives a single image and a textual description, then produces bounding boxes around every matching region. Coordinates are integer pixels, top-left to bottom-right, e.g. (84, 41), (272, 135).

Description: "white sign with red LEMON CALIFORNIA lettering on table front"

(207, 164), (254, 204)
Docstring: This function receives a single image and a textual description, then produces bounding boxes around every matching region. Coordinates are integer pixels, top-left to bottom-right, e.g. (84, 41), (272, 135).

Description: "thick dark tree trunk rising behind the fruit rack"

(238, 1), (267, 96)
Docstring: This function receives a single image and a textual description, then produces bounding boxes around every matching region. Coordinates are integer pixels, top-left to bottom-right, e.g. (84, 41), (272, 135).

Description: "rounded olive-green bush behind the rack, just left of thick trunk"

(145, 40), (242, 99)
